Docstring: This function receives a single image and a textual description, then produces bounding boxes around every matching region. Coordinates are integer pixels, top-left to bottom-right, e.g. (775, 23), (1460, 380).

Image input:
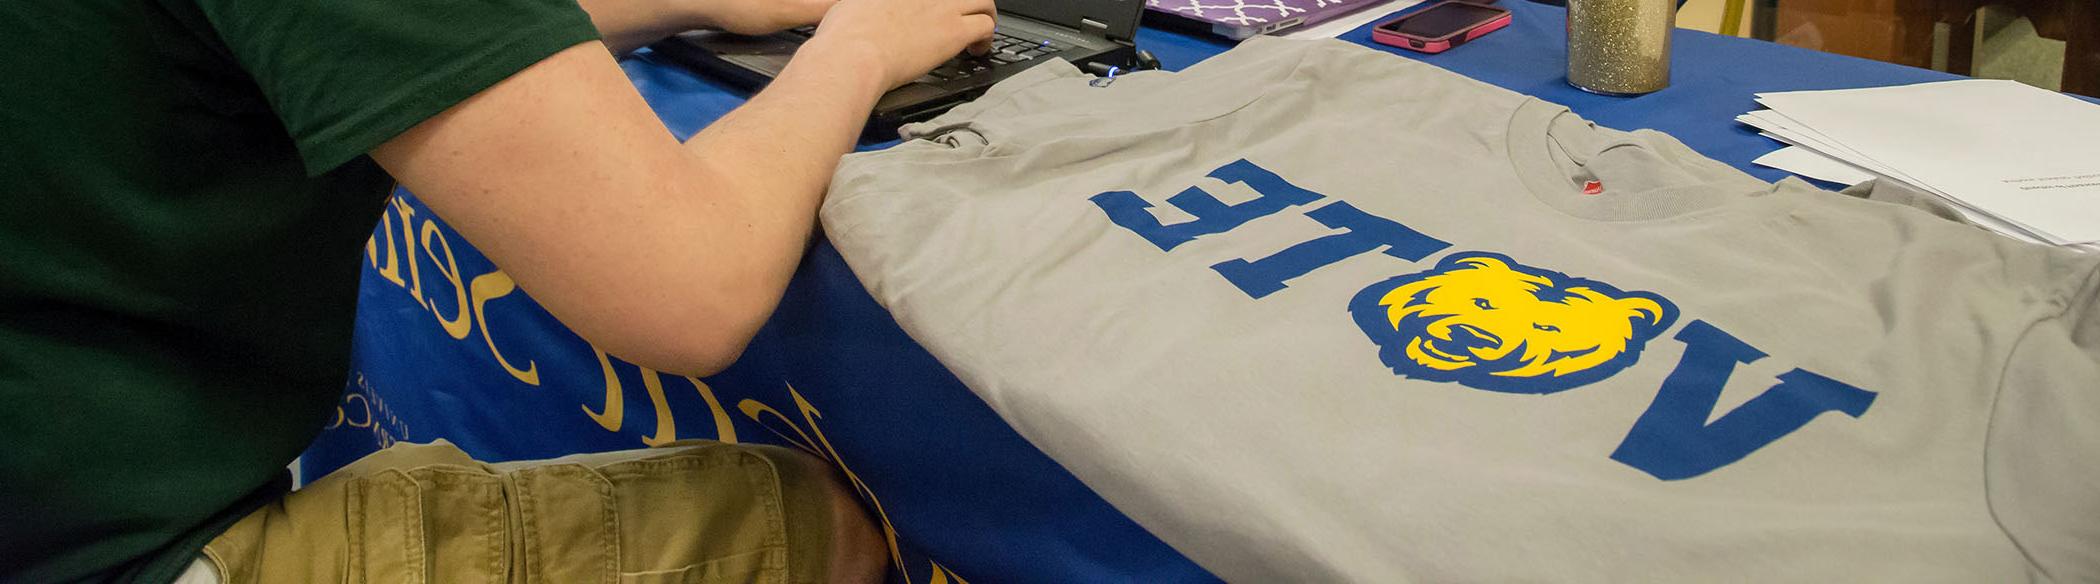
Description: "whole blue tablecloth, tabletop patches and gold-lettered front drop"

(305, 2), (1951, 582)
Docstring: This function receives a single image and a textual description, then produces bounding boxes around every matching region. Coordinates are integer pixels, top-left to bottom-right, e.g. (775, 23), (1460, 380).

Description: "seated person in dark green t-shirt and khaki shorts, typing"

(0, 0), (995, 582)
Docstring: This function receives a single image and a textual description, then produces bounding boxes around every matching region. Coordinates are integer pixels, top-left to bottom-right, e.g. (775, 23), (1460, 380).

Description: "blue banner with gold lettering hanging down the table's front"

(302, 184), (1214, 584)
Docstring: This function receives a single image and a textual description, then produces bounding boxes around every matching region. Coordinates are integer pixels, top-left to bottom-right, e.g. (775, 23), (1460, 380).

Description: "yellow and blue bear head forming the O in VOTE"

(1350, 252), (1676, 393)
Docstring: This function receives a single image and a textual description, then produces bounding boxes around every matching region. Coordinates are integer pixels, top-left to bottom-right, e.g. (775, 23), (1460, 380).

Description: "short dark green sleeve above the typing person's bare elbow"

(195, 0), (599, 174)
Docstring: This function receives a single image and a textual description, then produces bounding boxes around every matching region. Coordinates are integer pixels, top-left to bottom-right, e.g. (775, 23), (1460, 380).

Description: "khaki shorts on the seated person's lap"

(204, 441), (840, 584)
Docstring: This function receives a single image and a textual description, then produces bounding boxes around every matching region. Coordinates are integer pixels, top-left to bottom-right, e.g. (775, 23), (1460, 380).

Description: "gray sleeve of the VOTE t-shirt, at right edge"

(1985, 262), (2100, 582)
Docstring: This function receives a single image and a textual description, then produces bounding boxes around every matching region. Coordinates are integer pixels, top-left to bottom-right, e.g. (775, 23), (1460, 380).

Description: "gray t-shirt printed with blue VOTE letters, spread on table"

(823, 38), (2100, 582)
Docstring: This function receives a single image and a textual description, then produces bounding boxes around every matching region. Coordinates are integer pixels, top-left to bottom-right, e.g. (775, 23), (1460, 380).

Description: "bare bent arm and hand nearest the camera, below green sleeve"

(372, 0), (993, 374)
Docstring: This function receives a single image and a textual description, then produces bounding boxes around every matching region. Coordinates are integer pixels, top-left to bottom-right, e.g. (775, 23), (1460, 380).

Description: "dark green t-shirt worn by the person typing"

(0, 0), (596, 582)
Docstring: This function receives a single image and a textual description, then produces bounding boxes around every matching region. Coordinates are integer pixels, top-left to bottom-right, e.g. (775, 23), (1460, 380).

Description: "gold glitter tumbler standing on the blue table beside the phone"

(1569, 0), (1678, 95)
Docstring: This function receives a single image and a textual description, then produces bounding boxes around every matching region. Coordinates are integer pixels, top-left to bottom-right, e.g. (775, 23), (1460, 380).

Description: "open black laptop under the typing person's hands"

(651, 0), (1150, 141)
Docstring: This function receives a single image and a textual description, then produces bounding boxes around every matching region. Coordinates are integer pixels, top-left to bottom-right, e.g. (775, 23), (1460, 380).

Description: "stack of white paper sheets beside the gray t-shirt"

(1737, 80), (2100, 246)
